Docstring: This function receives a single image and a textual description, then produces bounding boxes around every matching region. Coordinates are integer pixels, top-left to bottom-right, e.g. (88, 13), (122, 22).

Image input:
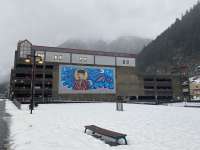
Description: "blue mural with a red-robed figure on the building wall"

(59, 65), (116, 94)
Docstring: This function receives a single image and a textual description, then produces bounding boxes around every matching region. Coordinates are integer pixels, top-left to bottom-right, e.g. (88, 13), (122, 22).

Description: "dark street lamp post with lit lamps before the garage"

(25, 50), (43, 114)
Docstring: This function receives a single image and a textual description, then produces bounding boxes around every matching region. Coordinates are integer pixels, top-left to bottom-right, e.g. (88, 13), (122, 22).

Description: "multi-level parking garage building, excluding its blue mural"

(10, 40), (176, 103)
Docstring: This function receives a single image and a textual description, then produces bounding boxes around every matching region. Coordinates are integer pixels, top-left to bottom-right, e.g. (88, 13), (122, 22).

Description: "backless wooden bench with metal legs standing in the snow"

(85, 125), (127, 145)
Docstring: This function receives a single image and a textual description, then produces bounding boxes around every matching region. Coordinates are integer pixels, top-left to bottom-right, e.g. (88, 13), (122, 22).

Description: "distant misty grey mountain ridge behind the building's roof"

(60, 36), (151, 54)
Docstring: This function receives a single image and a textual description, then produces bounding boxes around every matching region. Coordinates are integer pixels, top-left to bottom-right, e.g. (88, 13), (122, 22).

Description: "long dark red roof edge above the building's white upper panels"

(32, 45), (137, 58)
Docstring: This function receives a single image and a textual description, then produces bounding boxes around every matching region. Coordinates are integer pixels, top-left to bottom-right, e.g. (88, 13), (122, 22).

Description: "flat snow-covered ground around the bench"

(6, 101), (200, 150)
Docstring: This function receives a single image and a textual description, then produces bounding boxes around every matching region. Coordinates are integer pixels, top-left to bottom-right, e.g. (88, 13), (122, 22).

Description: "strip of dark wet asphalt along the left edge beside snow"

(0, 100), (9, 150)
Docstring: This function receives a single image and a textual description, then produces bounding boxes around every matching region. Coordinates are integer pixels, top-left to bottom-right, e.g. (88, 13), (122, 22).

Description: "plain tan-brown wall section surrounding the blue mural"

(50, 64), (144, 101)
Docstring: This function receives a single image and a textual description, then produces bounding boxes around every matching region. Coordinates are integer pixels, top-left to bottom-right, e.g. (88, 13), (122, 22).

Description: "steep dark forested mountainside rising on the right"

(137, 2), (200, 73)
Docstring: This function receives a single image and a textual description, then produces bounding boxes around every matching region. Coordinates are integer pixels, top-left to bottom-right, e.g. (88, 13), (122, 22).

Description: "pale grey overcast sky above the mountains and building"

(0, 0), (197, 82)
